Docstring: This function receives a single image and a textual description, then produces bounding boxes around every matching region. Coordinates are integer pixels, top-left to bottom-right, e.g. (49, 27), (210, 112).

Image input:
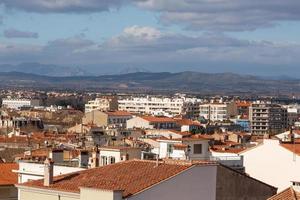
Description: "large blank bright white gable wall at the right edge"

(240, 139), (300, 192)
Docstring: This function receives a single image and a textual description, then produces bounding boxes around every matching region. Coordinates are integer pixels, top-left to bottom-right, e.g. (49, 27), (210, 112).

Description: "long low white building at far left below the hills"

(2, 98), (40, 109)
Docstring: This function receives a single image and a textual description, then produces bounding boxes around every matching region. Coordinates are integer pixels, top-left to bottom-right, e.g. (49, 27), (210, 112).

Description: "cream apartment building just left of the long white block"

(85, 96), (118, 113)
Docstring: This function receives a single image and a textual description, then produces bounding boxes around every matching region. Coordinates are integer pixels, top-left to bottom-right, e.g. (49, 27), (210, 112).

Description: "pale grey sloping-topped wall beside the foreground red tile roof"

(128, 166), (217, 200)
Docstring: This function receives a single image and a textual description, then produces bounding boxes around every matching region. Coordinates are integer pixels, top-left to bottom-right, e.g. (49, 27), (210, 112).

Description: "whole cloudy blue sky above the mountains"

(0, 0), (300, 77)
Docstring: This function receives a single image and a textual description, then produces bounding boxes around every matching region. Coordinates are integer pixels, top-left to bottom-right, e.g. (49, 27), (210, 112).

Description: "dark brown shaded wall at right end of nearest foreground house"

(216, 166), (276, 200)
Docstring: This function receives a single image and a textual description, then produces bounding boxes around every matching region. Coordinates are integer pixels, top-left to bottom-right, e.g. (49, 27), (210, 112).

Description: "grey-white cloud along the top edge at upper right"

(134, 0), (300, 31)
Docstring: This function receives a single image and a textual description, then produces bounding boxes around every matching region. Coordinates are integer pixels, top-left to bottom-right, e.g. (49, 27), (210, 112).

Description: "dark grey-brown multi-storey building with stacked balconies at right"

(249, 101), (288, 135)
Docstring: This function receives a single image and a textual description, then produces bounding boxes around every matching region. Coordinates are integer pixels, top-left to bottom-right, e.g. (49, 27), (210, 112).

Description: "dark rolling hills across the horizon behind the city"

(0, 72), (300, 95)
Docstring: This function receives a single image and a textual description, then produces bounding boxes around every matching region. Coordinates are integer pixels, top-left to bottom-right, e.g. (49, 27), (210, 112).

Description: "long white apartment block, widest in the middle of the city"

(118, 96), (200, 117)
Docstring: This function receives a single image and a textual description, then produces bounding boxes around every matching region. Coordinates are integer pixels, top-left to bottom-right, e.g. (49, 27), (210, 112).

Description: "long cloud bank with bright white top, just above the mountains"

(0, 26), (300, 76)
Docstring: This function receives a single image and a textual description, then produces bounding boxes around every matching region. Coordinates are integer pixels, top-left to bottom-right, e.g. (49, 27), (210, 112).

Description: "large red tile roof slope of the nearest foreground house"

(21, 160), (216, 198)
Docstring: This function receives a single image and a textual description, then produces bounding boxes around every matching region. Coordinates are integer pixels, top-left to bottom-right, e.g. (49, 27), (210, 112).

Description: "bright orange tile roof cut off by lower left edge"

(0, 163), (19, 186)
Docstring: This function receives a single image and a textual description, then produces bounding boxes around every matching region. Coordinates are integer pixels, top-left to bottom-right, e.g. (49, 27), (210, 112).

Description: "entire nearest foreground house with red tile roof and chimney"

(17, 160), (276, 200)
